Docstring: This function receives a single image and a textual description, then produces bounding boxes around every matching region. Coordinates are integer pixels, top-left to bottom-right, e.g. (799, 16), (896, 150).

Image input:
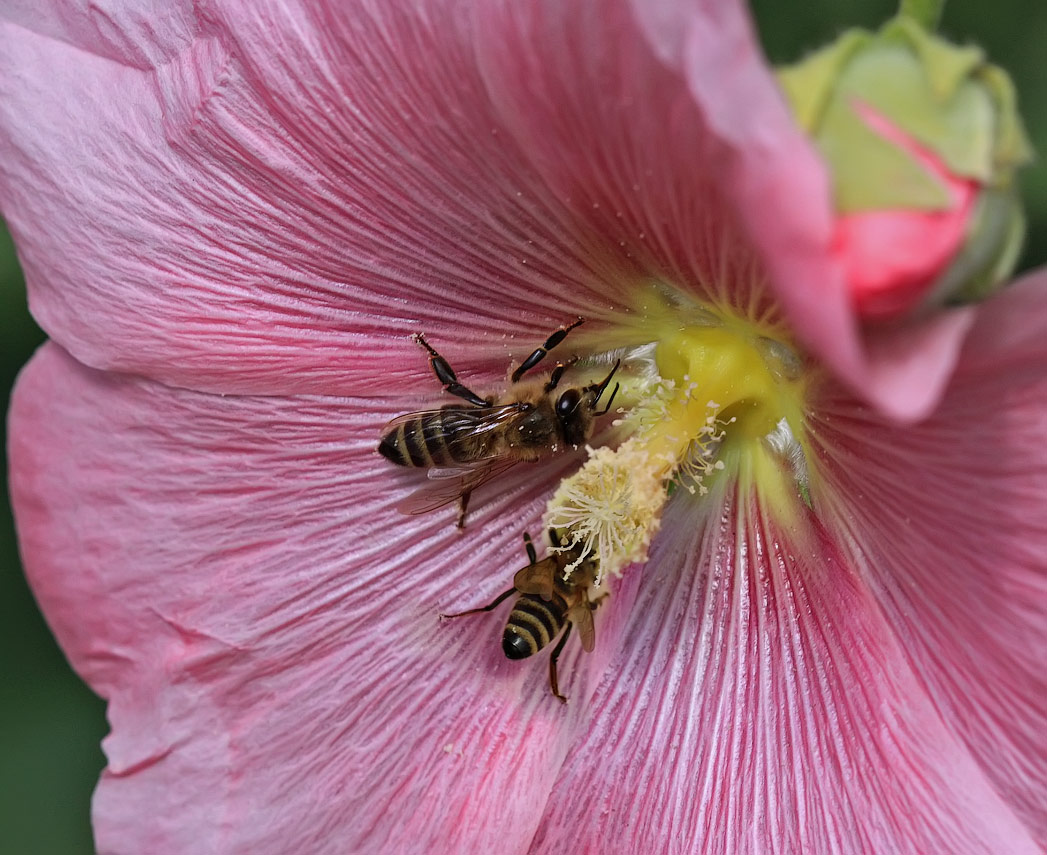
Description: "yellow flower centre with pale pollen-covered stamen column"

(543, 295), (809, 580)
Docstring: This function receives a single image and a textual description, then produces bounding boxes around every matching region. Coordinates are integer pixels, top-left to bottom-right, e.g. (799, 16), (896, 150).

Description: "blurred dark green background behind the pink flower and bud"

(0, 0), (1047, 855)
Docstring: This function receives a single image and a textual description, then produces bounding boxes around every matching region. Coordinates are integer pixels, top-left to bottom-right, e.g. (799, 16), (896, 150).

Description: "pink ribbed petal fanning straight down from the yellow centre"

(531, 489), (1040, 855)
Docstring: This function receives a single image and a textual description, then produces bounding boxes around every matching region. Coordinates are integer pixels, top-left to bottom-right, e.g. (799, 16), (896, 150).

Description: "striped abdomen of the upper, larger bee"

(378, 407), (486, 469)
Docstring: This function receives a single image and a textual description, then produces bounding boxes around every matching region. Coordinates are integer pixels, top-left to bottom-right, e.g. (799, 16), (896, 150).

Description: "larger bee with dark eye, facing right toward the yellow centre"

(378, 318), (620, 528)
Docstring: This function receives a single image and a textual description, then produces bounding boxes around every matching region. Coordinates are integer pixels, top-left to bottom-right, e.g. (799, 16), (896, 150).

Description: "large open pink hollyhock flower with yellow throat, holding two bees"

(0, 0), (1047, 855)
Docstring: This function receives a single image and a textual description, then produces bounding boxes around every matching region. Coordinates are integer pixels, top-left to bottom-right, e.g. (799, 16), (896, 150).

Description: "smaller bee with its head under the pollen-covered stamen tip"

(440, 528), (607, 703)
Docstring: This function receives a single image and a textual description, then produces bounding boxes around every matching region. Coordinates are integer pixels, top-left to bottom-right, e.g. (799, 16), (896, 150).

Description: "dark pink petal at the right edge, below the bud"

(815, 272), (1047, 846)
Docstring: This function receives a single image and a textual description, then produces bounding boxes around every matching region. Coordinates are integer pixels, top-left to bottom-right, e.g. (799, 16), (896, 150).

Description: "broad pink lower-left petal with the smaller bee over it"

(10, 345), (628, 855)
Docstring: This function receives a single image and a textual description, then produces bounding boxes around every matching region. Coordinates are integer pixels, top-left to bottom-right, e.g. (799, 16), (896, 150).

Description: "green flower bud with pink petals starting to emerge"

(779, 16), (1031, 319)
